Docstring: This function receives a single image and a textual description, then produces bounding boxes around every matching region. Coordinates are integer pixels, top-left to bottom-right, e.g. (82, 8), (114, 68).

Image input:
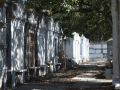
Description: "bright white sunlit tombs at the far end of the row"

(63, 32), (90, 65)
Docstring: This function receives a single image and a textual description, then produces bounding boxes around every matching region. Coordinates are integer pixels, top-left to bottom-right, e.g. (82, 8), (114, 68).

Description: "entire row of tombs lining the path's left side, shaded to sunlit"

(0, 0), (89, 89)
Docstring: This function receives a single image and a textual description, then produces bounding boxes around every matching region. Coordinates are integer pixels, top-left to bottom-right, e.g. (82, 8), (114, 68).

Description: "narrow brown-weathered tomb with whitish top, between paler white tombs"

(25, 9), (38, 80)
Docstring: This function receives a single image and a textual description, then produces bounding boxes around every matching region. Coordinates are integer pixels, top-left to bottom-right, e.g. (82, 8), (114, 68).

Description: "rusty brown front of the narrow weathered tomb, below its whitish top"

(25, 29), (36, 80)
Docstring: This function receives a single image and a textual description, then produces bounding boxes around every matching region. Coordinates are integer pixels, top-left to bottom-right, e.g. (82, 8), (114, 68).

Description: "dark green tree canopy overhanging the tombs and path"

(25, 0), (112, 41)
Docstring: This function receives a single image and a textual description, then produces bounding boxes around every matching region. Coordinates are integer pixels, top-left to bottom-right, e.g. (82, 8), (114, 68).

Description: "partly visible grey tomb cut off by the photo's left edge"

(0, 0), (7, 89)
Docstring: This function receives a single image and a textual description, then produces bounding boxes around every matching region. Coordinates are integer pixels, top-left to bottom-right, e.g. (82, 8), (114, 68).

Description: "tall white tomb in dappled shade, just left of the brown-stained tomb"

(7, 0), (26, 87)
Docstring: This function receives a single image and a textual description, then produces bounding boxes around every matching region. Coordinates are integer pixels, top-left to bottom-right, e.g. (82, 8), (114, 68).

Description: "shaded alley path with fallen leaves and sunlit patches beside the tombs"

(9, 60), (114, 90)
